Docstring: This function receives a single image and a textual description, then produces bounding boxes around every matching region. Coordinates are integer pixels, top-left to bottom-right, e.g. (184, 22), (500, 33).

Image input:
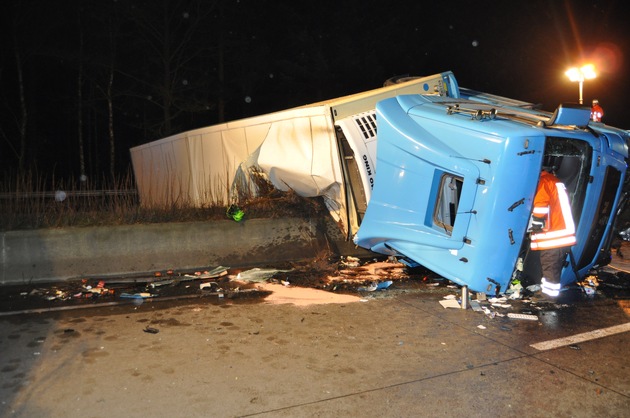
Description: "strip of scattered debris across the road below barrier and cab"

(0, 245), (630, 314)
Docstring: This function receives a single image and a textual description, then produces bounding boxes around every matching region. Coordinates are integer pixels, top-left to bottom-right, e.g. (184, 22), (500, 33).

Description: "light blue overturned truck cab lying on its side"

(354, 76), (628, 294)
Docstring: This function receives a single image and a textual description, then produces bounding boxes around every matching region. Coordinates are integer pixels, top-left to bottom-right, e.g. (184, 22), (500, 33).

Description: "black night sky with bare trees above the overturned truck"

(0, 0), (630, 178)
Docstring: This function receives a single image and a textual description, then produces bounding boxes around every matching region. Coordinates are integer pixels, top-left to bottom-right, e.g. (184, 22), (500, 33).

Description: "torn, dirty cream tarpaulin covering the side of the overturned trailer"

(131, 104), (345, 225)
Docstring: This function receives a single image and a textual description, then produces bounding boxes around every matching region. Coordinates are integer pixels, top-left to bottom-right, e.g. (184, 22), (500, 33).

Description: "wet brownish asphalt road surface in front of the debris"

(0, 256), (630, 418)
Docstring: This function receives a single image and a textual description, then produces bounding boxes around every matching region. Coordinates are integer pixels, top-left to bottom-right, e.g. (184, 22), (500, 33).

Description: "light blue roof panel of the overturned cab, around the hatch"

(355, 96), (545, 292)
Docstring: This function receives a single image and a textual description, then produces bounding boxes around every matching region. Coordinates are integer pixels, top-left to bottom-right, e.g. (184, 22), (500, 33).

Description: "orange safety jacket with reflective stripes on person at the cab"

(531, 171), (576, 250)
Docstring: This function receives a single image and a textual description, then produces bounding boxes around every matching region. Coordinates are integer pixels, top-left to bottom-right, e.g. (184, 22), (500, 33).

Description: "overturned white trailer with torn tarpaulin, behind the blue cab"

(131, 72), (459, 237)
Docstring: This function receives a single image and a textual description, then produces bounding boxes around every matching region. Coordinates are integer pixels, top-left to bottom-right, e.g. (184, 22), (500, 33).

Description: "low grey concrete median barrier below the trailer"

(0, 218), (370, 285)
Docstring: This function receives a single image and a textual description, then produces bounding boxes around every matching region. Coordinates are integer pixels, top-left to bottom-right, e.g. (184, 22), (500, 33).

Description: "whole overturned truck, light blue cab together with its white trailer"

(130, 71), (629, 293)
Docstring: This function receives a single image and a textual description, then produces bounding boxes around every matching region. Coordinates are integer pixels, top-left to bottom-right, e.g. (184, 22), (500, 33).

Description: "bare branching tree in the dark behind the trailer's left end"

(125, 0), (218, 136)
